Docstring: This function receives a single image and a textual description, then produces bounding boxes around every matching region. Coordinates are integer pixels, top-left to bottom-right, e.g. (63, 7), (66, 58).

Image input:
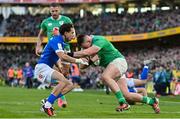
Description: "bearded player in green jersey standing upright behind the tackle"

(36, 3), (72, 107)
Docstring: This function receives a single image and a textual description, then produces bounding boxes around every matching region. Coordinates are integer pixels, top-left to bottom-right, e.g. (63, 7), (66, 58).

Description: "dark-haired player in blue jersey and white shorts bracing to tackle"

(35, 24), (88, 116)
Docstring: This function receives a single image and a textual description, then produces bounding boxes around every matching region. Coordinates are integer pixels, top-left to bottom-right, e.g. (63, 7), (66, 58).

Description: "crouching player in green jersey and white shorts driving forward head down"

(71, 35), (160, 113)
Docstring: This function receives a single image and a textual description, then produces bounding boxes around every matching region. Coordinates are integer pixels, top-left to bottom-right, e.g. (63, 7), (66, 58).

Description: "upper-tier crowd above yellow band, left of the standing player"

(4, 14), (47, 36)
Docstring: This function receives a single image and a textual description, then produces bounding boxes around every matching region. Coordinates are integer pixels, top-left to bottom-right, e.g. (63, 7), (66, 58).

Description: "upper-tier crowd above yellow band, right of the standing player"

(75, 10), (180, 35)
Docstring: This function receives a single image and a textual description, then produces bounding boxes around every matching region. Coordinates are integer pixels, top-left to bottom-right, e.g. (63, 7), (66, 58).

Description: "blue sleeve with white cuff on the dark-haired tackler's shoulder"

(50, 36), (64, 53)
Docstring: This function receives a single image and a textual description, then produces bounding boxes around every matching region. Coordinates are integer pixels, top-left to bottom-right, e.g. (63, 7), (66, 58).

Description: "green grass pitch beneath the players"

(0, 87), (180, 118)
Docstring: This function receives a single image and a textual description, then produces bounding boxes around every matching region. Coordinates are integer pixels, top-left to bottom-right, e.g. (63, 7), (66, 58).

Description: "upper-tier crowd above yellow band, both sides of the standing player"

(4, 9), (180, 36)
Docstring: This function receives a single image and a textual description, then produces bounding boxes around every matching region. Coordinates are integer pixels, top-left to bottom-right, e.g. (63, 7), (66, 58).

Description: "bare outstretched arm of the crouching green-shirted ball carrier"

(73, 45), (100, 58)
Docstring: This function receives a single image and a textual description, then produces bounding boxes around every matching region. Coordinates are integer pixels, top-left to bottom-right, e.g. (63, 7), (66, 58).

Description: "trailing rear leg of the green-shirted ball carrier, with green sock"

(117, 77), (160, 113)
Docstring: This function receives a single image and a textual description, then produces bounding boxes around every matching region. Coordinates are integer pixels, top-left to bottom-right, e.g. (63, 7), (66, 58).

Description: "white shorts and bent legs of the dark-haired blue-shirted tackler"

(35, 64), (72, 116)
